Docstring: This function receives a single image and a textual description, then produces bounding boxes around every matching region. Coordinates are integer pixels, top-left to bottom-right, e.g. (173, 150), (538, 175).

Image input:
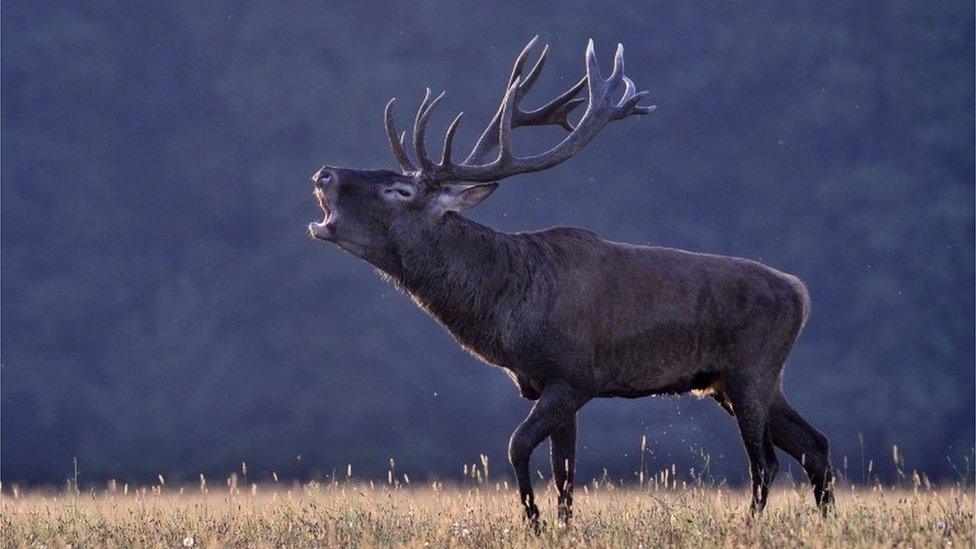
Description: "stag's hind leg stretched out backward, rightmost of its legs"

(769, 392), (834, 516)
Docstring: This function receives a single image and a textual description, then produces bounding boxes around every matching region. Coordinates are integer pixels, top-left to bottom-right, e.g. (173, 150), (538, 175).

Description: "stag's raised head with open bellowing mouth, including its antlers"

(308, 37), (655, 267)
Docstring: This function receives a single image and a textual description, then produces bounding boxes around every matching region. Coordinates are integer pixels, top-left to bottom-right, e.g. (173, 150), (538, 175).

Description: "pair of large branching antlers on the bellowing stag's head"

(385, 37), (656, 184)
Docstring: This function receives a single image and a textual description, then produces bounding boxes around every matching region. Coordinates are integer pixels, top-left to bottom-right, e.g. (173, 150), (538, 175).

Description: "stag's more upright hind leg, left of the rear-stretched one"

(723, 376), (779, 515)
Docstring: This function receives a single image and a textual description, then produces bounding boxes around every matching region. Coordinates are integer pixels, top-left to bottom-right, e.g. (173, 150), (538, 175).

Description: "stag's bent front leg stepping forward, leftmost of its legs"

(508, 380), (589, 527)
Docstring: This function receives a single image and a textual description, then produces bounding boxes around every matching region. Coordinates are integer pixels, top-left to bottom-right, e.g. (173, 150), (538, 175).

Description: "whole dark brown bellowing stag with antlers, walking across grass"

(309, 39), (833, 525)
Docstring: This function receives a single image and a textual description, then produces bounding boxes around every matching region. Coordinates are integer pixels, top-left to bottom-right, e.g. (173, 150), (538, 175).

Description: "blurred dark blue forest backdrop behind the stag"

(0, 0), (976, 483)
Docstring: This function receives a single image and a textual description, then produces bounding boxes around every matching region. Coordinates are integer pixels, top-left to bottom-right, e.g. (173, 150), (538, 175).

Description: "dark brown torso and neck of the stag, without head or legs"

(384, 215), (809, 400)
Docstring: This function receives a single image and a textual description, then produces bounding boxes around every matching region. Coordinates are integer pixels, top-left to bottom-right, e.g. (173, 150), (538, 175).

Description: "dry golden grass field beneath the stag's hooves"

(0, 482), (974, 547)
